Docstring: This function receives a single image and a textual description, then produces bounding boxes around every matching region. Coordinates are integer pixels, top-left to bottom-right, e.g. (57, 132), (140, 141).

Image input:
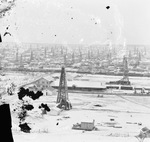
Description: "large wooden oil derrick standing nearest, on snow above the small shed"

(57, 67), (72, 110)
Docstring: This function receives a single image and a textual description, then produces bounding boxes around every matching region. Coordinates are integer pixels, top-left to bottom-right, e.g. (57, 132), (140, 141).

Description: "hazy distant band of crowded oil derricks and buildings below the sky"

(0, 43), (150, 77)
